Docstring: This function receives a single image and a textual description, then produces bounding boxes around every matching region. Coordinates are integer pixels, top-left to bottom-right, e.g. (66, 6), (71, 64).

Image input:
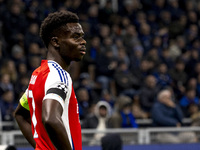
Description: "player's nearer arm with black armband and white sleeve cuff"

(42, 83), (72, 150)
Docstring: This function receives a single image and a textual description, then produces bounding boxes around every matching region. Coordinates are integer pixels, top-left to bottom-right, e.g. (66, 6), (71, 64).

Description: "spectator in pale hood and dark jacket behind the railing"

(81, 101), (112, 145)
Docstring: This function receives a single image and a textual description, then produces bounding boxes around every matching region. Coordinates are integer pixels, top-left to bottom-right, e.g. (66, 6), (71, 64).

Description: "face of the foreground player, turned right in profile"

(57, 23), (86, 62)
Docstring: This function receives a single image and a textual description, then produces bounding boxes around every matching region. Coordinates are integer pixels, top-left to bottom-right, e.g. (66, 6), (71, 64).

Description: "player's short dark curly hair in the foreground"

(40, 11), (79, 47)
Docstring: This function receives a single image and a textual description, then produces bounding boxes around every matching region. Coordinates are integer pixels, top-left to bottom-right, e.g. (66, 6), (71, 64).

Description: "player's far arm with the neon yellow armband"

(14, 94), (36, 148)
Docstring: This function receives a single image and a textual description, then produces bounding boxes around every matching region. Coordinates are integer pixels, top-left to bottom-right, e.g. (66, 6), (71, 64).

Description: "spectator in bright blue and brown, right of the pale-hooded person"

(110, 96), (138, 128)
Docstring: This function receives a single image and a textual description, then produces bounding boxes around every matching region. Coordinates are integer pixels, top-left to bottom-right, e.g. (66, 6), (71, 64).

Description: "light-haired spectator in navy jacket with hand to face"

(152, 89), (197, 143)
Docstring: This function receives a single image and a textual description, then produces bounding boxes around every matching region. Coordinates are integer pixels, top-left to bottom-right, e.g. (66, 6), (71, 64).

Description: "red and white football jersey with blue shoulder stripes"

(22, 60), (82, 150)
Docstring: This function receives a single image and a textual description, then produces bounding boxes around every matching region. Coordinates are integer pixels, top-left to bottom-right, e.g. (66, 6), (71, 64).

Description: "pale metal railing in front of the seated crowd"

(0, 127), (200, 147)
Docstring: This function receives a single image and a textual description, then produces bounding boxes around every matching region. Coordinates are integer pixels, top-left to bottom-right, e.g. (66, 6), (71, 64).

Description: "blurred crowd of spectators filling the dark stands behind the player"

(0, 0), (200, 132)
